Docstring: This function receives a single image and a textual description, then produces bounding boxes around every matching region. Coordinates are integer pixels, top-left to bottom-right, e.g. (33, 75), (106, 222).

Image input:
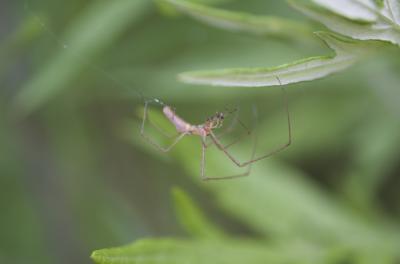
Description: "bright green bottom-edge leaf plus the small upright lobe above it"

(92, 189), (349, 264)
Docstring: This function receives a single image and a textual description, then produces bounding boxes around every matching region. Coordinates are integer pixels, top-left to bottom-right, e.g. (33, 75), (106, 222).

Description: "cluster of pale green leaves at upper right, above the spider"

(165, 0), (400, 87)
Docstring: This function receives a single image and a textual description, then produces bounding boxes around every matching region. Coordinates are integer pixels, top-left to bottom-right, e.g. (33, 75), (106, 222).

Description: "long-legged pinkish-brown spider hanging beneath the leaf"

(140, 87), (292, 180)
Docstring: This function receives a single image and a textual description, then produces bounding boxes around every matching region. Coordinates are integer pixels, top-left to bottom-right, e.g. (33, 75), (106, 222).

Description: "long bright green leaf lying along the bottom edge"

(91, 238), (347, 264)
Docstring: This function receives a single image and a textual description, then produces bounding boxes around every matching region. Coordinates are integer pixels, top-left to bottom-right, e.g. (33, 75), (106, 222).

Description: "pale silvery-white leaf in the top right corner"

(290, 0), (400, 45)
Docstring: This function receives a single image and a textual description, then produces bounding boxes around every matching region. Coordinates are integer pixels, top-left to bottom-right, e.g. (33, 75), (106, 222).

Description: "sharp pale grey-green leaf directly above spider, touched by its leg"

(179, 32), (376, 87)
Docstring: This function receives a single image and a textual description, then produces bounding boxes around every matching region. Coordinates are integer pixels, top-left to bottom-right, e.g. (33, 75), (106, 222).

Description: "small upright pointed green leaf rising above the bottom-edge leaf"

(172, 188), (225, 239)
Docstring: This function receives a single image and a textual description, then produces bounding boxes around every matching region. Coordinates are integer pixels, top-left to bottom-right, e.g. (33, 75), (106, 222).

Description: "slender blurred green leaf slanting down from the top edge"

(162, 0), (313, 42)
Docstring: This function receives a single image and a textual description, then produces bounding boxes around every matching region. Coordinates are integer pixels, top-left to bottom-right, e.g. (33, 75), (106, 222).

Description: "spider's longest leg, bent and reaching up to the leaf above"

(210, 88), (292, 167)
